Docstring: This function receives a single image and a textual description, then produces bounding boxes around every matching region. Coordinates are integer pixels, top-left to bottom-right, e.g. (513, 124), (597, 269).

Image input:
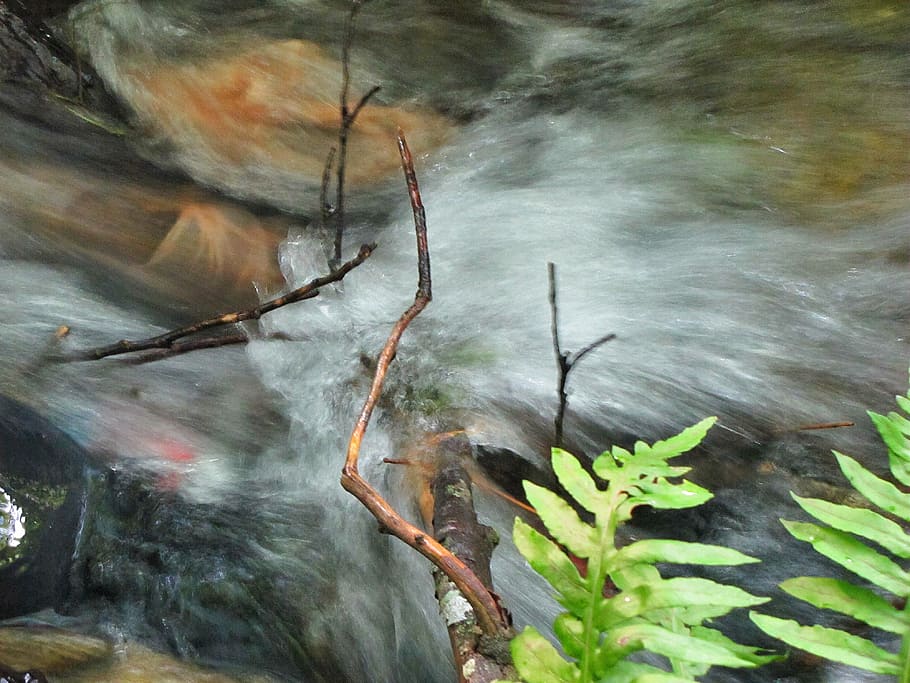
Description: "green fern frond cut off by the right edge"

(750, 374), (910, 683)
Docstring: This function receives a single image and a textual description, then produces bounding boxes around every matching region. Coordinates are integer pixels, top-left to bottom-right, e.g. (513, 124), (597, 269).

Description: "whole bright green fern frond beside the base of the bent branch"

(512, 418), (775, 683)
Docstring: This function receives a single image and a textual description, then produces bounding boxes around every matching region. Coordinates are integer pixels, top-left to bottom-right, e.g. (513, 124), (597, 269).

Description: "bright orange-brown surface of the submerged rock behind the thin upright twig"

(123, 40), (448, 184)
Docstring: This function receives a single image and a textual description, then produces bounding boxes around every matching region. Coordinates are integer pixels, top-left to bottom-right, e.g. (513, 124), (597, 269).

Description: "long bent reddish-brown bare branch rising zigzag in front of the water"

(341, 130), (508, 637)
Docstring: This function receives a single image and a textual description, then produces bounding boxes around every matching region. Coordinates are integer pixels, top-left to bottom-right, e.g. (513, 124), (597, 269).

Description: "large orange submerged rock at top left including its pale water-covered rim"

(71, 3), (454, 211)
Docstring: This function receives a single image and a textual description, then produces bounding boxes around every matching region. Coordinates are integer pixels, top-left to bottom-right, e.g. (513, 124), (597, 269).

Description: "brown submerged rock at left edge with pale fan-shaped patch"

(0, 90), (293, 320)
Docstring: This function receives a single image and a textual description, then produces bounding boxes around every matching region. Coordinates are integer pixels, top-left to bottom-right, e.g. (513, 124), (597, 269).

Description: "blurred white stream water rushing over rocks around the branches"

(0, 0), (910, 681)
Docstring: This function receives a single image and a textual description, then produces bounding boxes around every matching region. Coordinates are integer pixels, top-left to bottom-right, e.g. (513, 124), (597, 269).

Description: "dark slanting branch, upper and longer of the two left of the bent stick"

(68, 244), (376, 360)
